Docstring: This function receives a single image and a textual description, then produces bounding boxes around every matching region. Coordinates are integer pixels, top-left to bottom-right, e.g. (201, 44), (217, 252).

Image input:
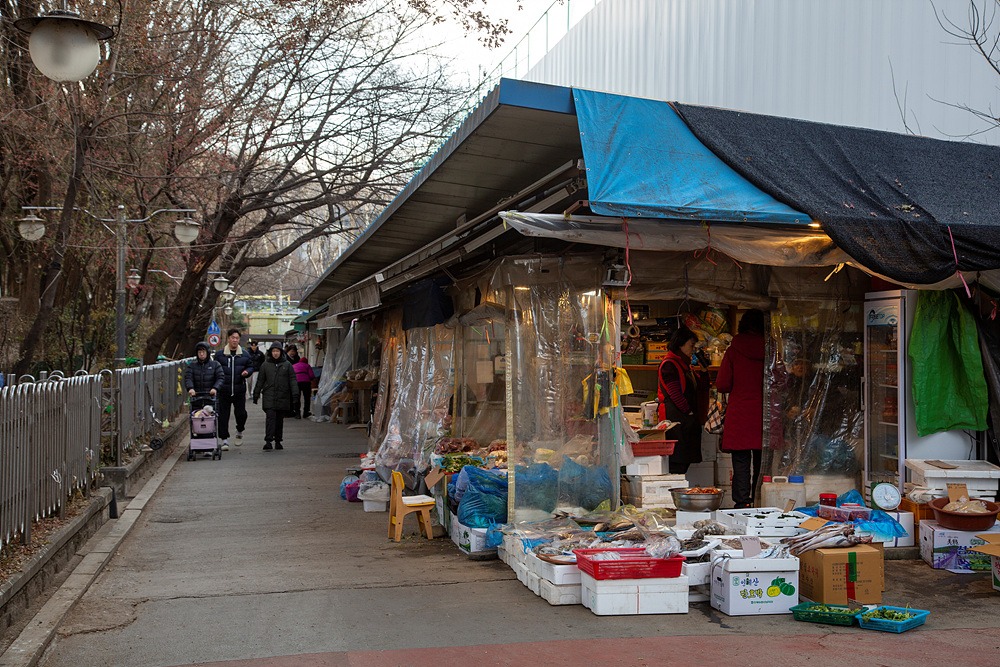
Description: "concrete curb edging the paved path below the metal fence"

(0, 441), (187, 667)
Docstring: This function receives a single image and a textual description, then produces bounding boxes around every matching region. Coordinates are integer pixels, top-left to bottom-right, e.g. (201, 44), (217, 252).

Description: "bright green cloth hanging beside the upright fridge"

(908, 290), (989, 436)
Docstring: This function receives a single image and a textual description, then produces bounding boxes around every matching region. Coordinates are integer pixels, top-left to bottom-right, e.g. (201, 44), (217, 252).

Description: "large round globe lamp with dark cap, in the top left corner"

(14, 8), (114, 82)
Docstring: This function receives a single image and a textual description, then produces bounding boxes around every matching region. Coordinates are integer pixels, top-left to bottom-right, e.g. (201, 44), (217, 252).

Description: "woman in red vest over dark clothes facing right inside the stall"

(656, 328), (706, 475)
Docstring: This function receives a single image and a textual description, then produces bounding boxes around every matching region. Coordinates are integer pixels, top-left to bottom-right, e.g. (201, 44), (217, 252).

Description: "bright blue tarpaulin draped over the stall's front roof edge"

(573, 90), (810, 224)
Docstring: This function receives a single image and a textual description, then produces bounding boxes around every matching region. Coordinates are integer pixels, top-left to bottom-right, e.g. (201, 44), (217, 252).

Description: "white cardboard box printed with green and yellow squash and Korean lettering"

(710, 557), (799, 616)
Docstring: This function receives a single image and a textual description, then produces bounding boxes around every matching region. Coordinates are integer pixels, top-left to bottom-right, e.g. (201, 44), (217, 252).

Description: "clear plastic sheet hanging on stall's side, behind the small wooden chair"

(375, 324), (455, 472)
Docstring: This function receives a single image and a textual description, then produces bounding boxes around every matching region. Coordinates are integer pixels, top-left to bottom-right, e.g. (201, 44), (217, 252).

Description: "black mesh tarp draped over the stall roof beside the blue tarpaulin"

(673, 104), (1000, 284)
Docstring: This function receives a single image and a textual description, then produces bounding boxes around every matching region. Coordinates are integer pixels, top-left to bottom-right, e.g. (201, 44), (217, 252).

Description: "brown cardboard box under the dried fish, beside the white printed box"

(799, 544), (885, 605)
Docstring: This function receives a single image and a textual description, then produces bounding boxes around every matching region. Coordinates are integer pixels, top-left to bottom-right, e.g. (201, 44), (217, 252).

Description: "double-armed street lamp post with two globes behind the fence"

(17, 205), (201, 365)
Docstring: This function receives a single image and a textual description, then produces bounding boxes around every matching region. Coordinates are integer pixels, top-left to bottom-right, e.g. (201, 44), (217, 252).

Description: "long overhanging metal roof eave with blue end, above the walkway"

(301, 79), (582, 307)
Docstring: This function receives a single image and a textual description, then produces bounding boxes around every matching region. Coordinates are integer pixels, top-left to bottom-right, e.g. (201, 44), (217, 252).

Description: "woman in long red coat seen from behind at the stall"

(715, 309), (764, 509)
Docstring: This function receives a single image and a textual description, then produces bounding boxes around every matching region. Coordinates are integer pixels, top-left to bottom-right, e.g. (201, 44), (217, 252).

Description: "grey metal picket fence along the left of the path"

(0, 361), (185, 548)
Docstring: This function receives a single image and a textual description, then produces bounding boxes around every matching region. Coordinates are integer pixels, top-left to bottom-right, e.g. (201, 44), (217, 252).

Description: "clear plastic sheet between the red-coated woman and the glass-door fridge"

(763, 295), (864, 488)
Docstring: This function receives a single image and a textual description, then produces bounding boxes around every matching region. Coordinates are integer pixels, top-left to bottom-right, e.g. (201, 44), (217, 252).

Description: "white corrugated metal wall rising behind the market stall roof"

(521, 0), (1000, 144)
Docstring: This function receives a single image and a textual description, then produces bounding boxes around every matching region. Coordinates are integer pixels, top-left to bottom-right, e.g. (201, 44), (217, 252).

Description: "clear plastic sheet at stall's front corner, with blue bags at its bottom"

(489, 257), (621, 522)
